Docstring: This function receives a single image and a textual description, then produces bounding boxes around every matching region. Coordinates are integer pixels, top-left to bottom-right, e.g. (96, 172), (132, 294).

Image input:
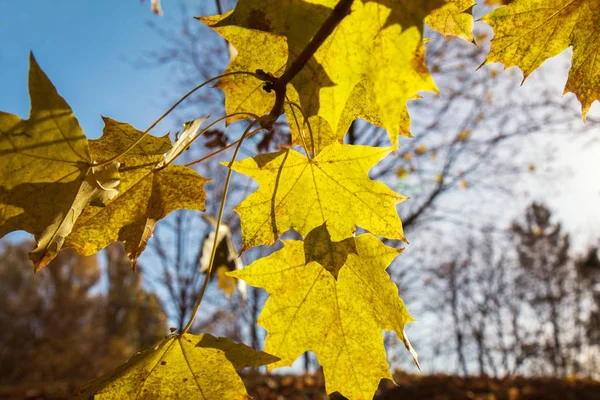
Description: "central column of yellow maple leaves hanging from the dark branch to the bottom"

(189, 0), (536, 399)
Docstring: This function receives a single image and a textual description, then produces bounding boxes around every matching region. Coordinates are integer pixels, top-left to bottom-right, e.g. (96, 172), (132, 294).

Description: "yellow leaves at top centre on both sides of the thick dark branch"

(200, 0), (445, 154)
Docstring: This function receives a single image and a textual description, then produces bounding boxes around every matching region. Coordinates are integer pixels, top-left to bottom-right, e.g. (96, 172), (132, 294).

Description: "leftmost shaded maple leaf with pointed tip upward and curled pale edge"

(0, 54), (119, 270)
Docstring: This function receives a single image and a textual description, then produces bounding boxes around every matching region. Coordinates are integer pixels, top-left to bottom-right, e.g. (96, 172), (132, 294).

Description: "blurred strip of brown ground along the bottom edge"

(0, 373), (600, 400)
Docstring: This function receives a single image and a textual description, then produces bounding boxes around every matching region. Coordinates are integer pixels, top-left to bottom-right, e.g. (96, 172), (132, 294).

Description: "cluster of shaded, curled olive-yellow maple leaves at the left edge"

(0, 55), (207, 269)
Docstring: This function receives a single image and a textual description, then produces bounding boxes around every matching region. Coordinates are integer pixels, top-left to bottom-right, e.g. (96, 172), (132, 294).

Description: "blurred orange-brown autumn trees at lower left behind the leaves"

(0, 242), (166, 387)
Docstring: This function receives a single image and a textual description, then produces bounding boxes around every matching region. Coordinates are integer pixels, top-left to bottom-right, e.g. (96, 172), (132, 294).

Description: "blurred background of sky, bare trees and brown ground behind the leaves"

(0, 0), (600, 399)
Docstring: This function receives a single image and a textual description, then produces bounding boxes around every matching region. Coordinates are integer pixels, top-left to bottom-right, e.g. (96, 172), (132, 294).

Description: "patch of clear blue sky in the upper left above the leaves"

(0, 0), (220, 138)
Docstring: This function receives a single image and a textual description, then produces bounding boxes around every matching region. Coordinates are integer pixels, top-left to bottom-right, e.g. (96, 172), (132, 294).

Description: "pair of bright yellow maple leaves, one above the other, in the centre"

(220, 122), (416, 399)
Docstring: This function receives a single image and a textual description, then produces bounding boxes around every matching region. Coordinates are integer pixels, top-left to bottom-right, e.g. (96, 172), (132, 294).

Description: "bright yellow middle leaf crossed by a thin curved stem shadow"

(227, 143), (406, 251)
